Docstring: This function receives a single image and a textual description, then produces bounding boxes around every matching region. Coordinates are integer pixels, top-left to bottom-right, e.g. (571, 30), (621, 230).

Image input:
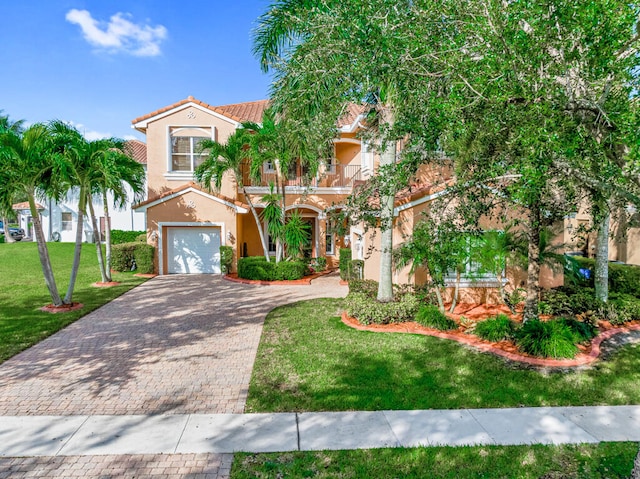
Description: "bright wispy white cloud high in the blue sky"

(65, 8), (167, 57)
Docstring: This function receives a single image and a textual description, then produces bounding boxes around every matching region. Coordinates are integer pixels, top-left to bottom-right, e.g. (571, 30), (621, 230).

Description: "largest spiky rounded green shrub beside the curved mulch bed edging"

(516, 320), (578, 358)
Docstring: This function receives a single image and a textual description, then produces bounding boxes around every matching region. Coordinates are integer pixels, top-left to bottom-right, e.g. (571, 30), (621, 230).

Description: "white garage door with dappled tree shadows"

(167, 227), (221, 274)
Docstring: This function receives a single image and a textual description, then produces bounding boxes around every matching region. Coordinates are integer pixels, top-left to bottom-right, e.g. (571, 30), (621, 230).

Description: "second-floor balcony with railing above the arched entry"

(242, 163), (364, 188)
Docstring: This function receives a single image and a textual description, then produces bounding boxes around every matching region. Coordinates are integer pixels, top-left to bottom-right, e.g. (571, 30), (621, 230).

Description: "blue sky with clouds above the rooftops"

(0, 0), (270, 139)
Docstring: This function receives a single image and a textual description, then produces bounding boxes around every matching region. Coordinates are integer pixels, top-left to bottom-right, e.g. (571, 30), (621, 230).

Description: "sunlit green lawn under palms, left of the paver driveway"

(0, 242), (145, 362)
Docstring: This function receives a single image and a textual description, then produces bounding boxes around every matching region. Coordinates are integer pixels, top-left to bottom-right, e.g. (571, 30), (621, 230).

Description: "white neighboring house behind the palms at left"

(13, 140), (147, 243)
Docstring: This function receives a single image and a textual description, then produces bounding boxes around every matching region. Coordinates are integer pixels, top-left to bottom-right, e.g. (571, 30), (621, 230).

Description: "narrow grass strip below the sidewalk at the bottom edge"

(231, 442), (638, 479)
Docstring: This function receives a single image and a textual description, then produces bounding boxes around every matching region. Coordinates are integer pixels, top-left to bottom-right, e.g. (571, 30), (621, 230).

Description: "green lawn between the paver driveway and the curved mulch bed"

(246, 299), (640, 412)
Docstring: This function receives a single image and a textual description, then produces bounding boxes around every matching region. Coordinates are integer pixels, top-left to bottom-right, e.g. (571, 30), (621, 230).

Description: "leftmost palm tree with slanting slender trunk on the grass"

(0, 123), (63, 306)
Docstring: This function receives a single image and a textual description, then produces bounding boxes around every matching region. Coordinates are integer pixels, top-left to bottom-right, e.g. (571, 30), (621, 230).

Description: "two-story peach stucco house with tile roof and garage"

(132, 97), (375, 274)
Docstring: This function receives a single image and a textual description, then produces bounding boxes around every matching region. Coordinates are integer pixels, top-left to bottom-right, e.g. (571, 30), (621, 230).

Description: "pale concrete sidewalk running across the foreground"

(0, 406), (640, 457)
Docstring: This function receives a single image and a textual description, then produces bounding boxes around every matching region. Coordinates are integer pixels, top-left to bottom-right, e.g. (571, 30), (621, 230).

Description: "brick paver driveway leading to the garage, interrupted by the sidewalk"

(0, 275), (347, 479)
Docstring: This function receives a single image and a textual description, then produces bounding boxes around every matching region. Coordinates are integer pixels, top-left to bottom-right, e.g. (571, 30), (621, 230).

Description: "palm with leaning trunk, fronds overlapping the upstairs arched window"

(194, 129), (269, 261)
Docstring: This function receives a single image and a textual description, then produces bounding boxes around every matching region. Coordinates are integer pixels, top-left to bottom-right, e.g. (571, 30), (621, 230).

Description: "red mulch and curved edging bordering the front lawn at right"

(342, 304), (640, 367)
